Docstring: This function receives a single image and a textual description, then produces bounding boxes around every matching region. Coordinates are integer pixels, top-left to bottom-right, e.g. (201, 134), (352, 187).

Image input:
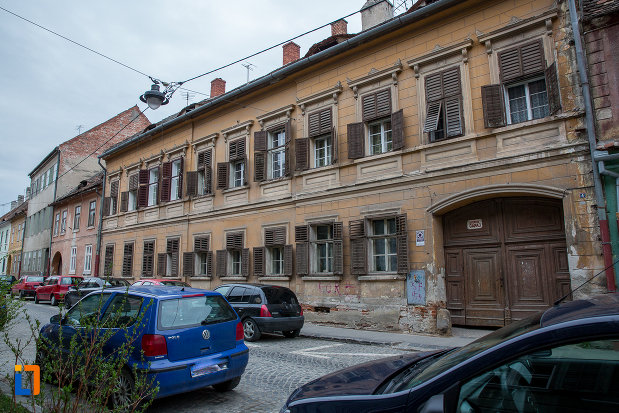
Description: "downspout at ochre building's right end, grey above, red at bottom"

(567, 0), (615, 292)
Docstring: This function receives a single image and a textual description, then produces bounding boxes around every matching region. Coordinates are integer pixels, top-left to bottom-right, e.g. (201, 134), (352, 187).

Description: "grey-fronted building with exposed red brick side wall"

(22, 106), (150, 274)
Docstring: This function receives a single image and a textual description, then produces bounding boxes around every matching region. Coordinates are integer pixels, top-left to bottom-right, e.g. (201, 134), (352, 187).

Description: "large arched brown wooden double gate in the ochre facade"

(443, 198), (570, 326)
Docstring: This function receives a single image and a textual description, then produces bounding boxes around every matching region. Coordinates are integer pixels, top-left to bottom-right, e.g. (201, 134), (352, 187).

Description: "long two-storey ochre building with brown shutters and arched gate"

(101, 0), (605, 333)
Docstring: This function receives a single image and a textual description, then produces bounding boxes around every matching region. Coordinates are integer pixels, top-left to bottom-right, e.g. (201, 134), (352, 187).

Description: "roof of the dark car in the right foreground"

(540, 293), (619, 327)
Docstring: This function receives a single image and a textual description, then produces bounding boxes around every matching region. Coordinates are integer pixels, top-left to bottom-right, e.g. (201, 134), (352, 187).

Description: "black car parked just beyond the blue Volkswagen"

(215, 284), (304, 341)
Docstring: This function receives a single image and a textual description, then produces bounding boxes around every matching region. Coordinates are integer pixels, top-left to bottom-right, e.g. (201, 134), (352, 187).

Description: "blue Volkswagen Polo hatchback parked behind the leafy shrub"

(37, 286), (249, 405)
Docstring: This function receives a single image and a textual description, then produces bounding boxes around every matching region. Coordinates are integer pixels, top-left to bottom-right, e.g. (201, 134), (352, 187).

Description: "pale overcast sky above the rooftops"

(0, 0), (411, 214)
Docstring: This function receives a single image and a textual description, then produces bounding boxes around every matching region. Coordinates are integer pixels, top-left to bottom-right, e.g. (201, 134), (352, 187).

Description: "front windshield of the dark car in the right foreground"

(383, 313), (542, 393)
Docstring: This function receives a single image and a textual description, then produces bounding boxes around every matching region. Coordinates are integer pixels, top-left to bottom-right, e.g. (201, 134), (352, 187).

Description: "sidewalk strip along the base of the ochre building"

(301, 323), (492, 351)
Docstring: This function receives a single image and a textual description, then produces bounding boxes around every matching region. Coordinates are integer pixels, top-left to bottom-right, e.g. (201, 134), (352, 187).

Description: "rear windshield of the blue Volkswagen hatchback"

(158, 295), (236, 329)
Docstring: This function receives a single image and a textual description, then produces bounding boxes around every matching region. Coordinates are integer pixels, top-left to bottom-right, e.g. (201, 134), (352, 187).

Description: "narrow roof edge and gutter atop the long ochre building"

(100, 0), (462, 159)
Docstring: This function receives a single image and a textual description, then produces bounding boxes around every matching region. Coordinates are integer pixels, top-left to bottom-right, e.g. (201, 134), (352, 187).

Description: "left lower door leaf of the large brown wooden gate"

(464, 248), (505, 326)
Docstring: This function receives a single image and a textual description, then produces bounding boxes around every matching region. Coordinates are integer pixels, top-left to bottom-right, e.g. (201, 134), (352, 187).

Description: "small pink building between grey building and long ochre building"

(50, 172), (103, 276)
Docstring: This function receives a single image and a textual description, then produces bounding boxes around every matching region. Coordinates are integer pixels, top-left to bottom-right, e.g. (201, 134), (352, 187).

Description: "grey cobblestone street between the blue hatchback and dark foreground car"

(0, 301), (414, 413)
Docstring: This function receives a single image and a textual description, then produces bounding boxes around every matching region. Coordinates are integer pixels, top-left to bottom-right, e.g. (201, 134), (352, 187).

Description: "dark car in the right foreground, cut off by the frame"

(281, 293), (619, 413)
